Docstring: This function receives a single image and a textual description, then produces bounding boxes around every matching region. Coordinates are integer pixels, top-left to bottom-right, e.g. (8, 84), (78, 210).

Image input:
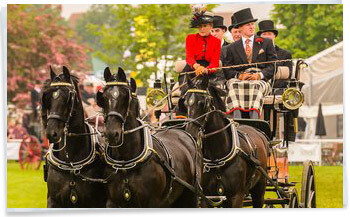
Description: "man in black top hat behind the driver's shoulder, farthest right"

(257, 20), (293, 88)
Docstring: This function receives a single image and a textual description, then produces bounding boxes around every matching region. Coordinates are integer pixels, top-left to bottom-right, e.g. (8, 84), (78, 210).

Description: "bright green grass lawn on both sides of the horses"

(7, 162), (343, 208)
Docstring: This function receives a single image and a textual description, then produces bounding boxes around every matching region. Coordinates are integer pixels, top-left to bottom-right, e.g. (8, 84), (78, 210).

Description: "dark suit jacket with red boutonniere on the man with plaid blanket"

(224, 36), (277, 80)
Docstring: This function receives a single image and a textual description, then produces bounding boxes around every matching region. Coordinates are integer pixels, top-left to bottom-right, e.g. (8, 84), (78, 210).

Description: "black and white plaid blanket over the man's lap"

(226, 78), (272, 113)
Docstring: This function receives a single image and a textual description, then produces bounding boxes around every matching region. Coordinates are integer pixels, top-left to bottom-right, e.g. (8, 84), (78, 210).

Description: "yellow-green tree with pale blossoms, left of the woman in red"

(79, 4), (216, 84)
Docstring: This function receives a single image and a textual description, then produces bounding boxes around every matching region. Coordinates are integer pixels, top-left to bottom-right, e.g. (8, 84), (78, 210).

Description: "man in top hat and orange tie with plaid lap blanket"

(224, 8), (277, 119)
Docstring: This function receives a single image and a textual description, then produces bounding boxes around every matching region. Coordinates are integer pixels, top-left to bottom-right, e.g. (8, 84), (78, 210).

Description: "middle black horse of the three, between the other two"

(96, 67), (201, 207)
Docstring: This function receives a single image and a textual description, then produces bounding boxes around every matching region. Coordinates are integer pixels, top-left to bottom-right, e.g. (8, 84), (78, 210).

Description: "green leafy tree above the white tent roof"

(272, 4), (343, 58)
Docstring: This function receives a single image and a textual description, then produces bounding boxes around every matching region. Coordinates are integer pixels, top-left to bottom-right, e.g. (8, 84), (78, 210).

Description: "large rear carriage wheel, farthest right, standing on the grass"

(301, 161), (316, 208)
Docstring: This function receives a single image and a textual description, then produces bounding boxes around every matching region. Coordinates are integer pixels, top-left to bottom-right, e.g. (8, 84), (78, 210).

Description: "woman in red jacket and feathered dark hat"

(176, 8), (221, 116)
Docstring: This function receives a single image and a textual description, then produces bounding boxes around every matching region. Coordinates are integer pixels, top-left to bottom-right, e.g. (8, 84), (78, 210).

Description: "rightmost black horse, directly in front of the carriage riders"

(185, 77), (268, 207)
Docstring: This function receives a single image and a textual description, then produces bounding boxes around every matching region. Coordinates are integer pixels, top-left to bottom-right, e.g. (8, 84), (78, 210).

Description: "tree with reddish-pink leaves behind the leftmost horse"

(7, 5), (90, 106)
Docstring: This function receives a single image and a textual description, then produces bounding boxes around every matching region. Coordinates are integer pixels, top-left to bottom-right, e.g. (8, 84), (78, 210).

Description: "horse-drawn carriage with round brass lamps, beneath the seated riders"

(147, 60), (316, 208)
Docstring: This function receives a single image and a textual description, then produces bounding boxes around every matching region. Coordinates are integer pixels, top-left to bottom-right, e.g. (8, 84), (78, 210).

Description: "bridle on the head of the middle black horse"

(104, 81), (133, 148)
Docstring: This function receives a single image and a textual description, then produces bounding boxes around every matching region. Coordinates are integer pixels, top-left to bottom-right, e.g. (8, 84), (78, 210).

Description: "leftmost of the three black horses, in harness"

(42, 66), (106, 208)
